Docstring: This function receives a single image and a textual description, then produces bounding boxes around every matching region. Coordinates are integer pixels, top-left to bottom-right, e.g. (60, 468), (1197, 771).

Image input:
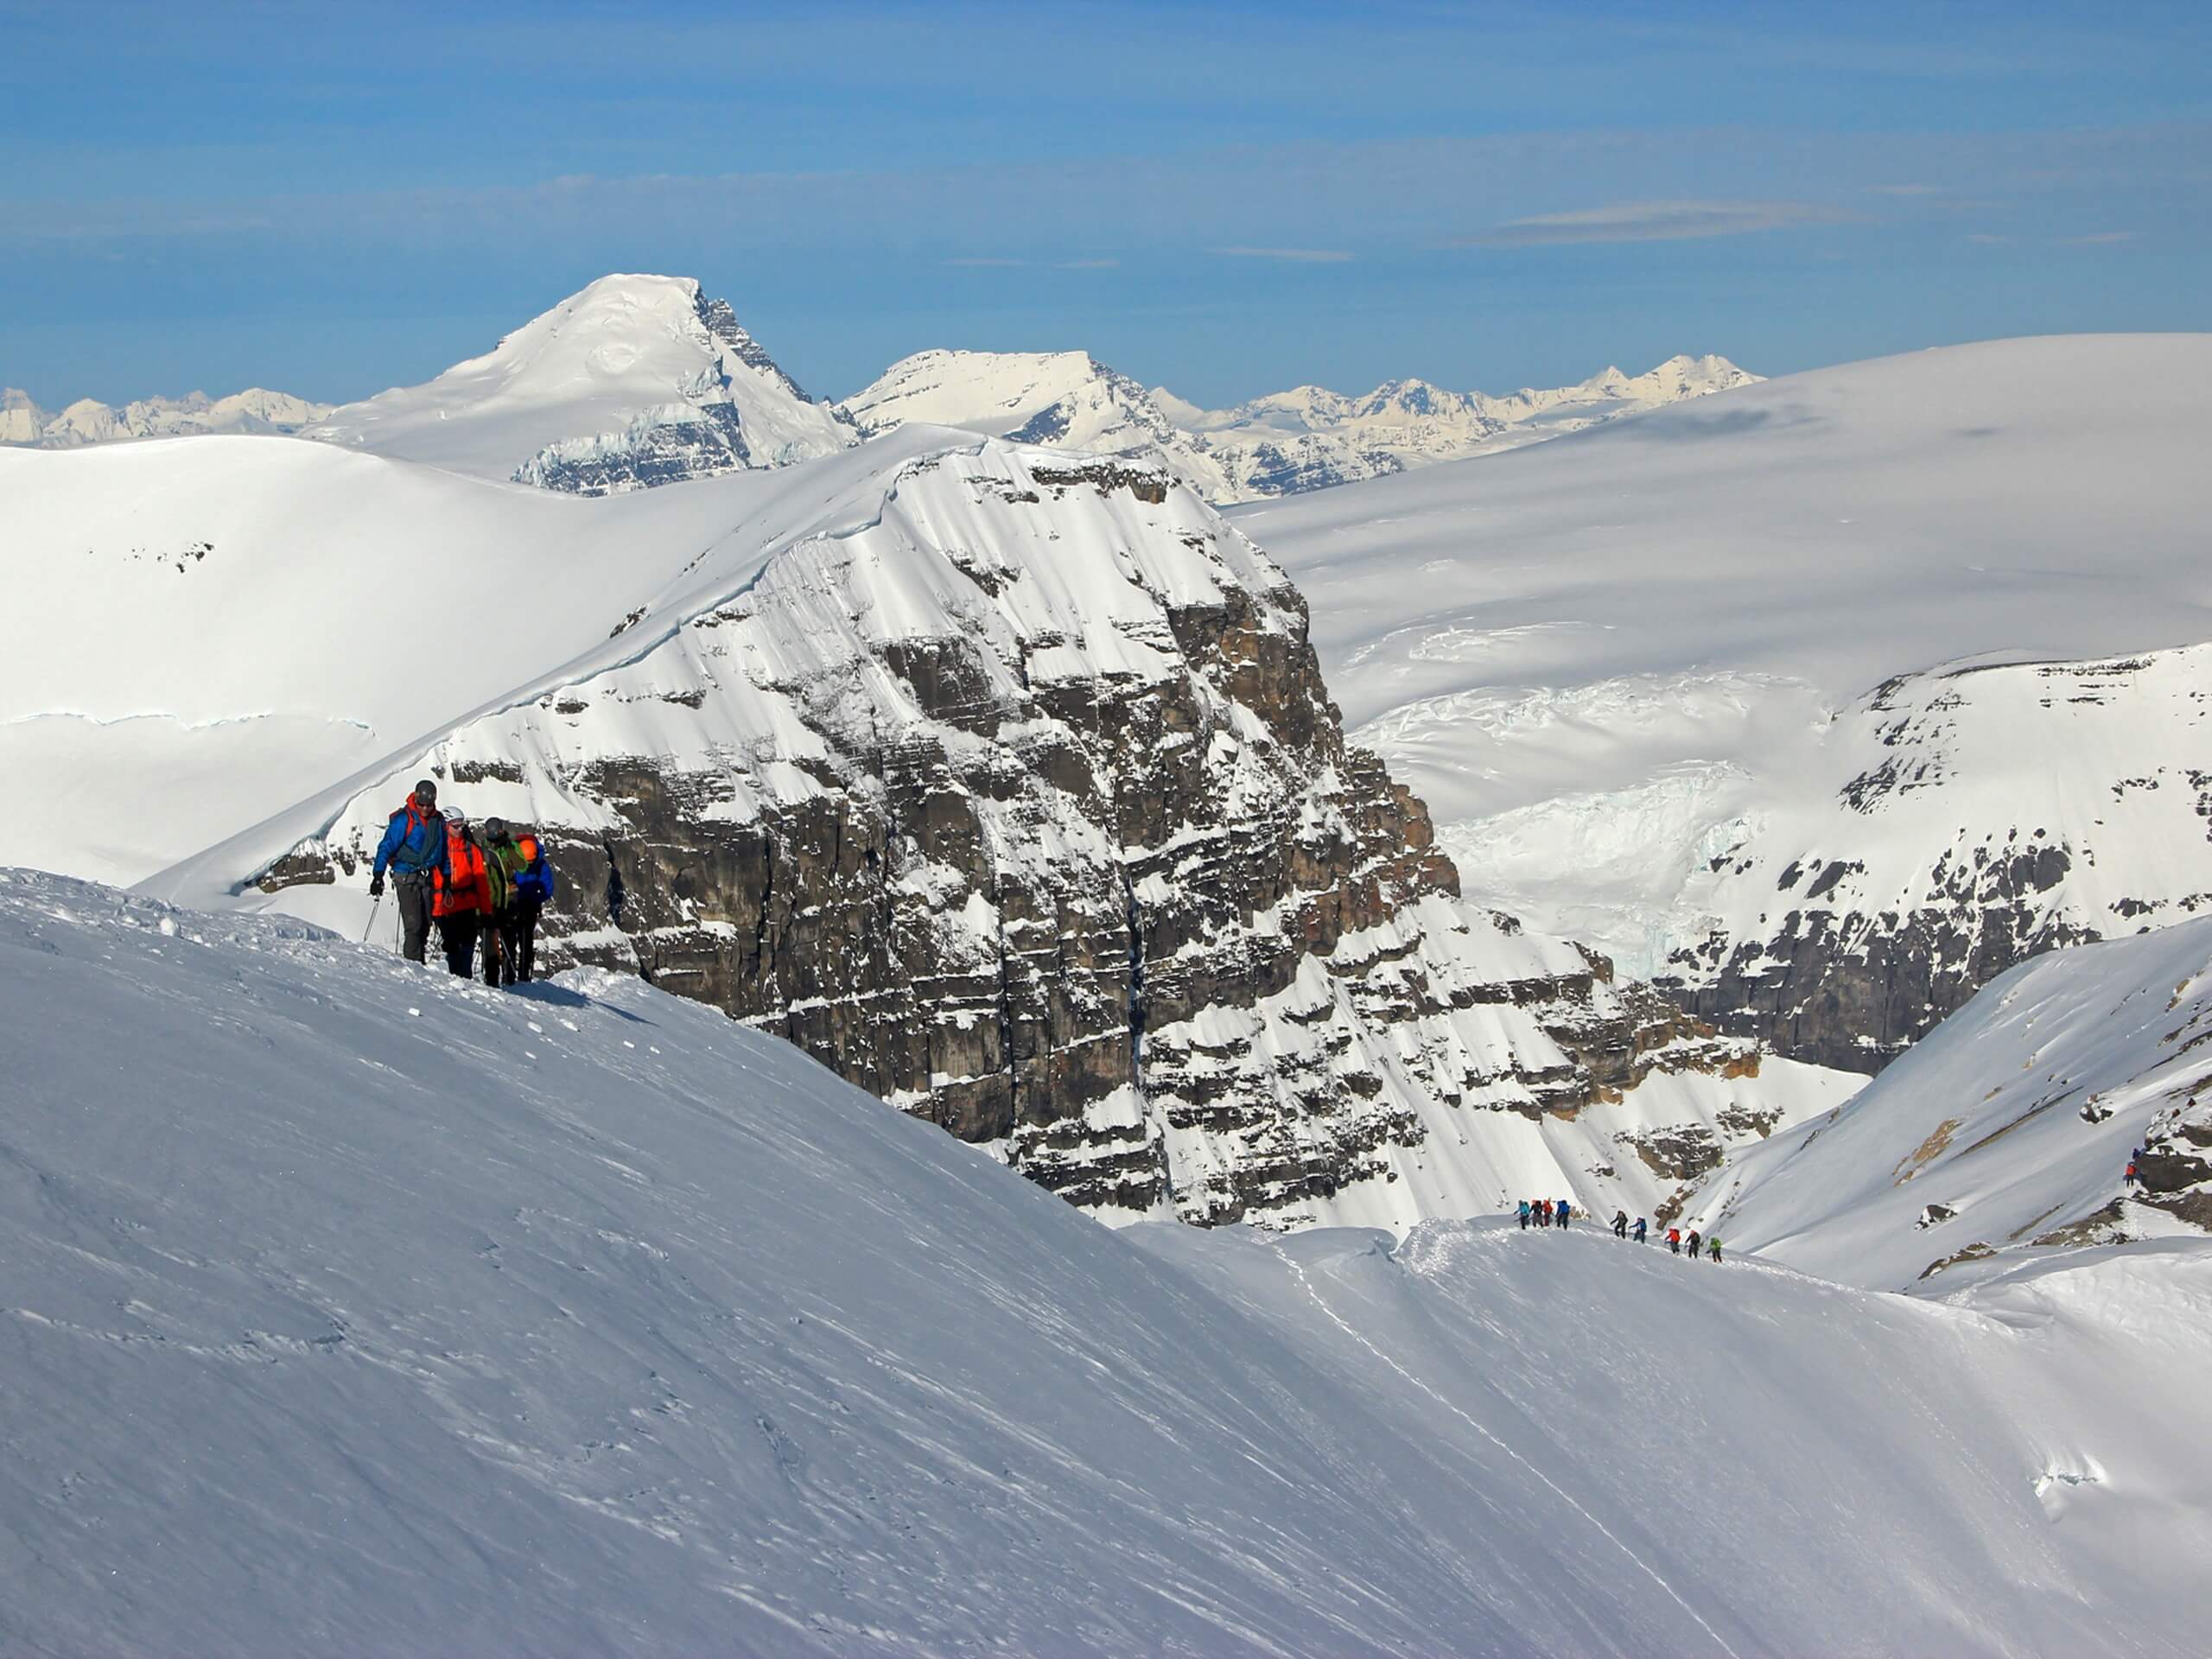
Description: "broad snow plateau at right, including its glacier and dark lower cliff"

(1232, 336), (2212, 1071)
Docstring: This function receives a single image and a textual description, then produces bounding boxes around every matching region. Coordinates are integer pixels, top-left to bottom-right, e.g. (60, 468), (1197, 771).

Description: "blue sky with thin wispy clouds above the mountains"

(0, 0), (2212, 407)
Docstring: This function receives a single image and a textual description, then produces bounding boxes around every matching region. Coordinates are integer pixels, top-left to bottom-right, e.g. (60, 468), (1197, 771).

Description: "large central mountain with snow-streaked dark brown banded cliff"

(268, 442), (1825, 1224)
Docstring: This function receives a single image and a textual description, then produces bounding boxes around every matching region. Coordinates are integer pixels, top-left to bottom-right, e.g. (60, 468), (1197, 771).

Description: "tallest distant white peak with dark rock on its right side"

(305, 274), (858, 495)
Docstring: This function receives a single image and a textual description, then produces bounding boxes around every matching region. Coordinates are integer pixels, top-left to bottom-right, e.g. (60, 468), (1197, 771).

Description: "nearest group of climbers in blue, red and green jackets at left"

(370, 779), (553, 984)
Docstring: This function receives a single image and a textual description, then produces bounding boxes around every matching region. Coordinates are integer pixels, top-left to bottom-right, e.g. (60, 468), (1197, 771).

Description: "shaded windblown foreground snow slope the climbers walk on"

(13, 872), (2212, 1659)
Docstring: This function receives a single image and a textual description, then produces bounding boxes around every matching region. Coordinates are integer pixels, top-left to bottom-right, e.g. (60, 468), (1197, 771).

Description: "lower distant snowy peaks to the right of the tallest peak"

(841, 334), (1758, 502)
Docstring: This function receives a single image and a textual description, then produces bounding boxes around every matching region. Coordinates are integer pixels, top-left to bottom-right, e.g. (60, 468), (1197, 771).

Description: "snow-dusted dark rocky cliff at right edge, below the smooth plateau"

(1662, 648), (2212, 1071)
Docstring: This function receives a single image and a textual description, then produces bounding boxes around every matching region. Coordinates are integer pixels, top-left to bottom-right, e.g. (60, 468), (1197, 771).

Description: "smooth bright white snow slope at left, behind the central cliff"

(0, 434), (964, 880)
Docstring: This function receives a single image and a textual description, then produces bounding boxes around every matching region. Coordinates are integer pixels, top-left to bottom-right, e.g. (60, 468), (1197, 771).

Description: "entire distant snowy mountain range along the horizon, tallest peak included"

(0, 274), (1758, 505)
